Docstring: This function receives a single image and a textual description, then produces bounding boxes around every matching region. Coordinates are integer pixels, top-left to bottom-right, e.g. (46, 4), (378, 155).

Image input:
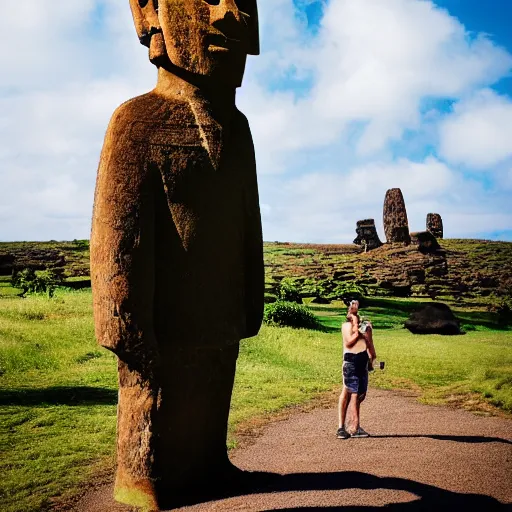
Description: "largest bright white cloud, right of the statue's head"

(240, 0), (512, 166)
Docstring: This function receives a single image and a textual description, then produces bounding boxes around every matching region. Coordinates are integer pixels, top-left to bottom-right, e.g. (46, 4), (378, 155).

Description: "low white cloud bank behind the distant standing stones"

(263, 157), (465, 243)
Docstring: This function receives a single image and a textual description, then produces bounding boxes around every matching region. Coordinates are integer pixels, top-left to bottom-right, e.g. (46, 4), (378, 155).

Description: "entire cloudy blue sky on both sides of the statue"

(0, 0), (512, 243)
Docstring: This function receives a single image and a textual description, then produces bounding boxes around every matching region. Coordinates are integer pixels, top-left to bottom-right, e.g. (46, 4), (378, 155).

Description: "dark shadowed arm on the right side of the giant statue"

(243, 116), (265, 338)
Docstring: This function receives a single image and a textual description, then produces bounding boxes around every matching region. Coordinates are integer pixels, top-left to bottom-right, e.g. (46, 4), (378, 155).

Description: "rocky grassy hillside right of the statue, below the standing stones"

(265, 239), (512, 303)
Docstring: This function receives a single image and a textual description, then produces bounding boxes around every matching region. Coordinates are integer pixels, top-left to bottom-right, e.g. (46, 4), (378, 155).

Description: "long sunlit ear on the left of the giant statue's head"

(130, 0), (167, 66)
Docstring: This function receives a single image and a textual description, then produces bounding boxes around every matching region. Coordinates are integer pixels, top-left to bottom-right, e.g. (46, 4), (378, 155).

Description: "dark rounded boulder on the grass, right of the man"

(404, 302), (462, 335)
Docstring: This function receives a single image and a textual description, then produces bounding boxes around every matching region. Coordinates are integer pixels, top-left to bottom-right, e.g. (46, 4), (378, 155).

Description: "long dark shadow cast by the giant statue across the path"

(165, 471), (512, 512)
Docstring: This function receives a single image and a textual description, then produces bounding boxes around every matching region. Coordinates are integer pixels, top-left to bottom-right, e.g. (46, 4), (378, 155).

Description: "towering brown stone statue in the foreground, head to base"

(91, 0), (264, 510)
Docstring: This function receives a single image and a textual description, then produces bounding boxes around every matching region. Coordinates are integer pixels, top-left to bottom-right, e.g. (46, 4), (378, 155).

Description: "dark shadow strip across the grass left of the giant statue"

(0, 386), (117, 405)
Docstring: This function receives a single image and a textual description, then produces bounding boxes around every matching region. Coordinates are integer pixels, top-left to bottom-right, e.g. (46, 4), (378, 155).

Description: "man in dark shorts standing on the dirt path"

(336, 301), (377, 439)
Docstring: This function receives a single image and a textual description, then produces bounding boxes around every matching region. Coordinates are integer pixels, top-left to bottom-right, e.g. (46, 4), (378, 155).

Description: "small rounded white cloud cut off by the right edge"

(440, 89), (512, 170)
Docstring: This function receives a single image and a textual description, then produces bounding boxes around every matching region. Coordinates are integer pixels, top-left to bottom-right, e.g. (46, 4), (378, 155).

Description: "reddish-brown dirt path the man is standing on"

(73, 390), (512, 512)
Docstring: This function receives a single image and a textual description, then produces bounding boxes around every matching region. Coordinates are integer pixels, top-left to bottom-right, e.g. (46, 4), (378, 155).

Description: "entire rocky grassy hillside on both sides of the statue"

(0, 239), (512, 304)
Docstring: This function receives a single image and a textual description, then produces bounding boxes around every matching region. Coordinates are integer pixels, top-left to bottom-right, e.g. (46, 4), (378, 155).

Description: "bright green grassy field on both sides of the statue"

(0, 281), (512, 512)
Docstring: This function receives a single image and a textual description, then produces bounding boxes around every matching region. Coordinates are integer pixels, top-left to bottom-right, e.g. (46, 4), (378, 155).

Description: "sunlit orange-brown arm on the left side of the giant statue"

(91, 107), (157, 368)
